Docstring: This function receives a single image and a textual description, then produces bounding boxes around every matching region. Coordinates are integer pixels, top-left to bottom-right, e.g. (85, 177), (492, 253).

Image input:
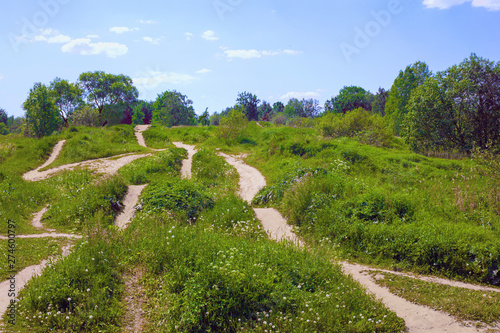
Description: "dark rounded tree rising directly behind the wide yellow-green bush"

(325, 86), (372, 114)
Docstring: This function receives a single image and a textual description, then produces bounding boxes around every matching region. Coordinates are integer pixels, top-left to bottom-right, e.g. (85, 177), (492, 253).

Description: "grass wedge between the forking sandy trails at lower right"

(370, 271), (500, 325)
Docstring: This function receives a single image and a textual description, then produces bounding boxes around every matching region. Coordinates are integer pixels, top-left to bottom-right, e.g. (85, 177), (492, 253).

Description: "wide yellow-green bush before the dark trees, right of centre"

(318, 108), (392, 147)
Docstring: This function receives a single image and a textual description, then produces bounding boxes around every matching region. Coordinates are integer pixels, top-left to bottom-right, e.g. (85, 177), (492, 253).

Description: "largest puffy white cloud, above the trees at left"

(61, 38), (128, 58)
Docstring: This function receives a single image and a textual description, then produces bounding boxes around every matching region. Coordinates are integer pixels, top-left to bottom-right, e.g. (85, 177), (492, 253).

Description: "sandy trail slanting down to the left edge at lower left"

(0, 244), (73, 322)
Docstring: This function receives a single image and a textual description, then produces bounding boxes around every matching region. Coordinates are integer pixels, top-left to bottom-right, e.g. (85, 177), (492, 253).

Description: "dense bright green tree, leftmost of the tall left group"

(23, 82), (60, 138)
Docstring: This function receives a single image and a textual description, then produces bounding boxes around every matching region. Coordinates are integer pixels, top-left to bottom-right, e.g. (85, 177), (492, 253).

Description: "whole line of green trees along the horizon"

(0, 54), (500, 153)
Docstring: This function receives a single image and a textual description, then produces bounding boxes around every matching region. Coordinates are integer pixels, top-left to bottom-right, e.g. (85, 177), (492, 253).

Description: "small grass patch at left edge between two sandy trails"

(0, 238), (68, 281)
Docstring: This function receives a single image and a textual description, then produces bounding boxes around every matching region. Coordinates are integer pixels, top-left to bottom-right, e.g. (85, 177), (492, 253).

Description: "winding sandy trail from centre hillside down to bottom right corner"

(219, 148), (496, 333)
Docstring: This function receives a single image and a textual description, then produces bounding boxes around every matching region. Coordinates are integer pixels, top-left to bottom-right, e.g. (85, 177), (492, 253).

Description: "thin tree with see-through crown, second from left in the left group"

(50, 77), (84, 126)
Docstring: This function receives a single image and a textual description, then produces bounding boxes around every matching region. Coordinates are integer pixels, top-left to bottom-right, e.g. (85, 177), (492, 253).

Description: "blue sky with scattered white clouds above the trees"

(0, 0), (500, 116)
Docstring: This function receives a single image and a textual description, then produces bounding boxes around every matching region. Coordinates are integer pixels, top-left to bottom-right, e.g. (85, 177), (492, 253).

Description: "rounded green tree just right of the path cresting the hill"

(153, 90), (196, 127)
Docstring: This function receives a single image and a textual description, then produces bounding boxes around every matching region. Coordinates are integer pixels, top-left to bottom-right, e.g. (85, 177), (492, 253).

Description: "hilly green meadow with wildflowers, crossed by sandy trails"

(0, 123), (500, 332)
